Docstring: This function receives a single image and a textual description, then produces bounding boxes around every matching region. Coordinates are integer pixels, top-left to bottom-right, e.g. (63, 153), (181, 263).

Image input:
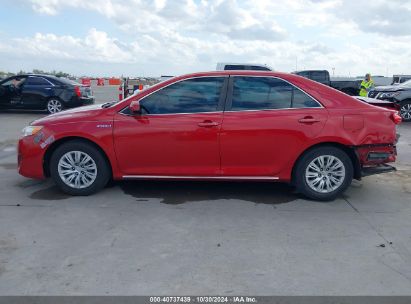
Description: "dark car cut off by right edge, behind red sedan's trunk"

(368, 80), (411, 121)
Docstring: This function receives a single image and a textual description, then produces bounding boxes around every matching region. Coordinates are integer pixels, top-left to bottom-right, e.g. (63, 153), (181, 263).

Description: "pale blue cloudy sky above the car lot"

(0, 0), (411, 77)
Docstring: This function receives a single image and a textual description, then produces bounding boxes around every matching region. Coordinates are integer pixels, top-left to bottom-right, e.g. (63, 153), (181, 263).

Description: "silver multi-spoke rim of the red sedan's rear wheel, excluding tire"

(305, 155), (345, 193)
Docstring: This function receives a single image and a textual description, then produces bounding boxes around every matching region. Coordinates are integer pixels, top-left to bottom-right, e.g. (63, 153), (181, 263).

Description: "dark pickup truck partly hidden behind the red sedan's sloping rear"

(293, 70), (361, 96)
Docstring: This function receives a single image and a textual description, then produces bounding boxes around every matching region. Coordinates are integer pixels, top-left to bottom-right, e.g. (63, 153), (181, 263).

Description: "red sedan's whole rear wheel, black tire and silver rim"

(294, 146), (354, 201)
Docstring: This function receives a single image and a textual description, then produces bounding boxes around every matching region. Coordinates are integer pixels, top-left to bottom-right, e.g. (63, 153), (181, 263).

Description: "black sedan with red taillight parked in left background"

(0, 74), (94, 113)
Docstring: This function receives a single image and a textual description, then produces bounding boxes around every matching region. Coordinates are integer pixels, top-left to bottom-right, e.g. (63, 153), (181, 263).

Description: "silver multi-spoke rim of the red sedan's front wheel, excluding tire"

(57, 151), (97, 189)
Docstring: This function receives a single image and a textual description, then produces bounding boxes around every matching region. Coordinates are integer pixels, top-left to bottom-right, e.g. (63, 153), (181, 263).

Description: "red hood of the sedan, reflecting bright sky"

(31, 104), (104, 125)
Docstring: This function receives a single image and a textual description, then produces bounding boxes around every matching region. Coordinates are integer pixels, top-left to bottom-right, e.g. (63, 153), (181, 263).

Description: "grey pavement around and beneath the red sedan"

(0, 91), (411, 295)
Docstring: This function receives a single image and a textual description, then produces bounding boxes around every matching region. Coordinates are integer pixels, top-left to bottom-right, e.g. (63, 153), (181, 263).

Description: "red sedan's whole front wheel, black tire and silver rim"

(50, 140), (111, 196)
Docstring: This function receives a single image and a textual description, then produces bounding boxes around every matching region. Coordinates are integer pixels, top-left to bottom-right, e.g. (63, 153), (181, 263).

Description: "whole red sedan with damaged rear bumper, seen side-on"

(18, 71), (401, 200)
